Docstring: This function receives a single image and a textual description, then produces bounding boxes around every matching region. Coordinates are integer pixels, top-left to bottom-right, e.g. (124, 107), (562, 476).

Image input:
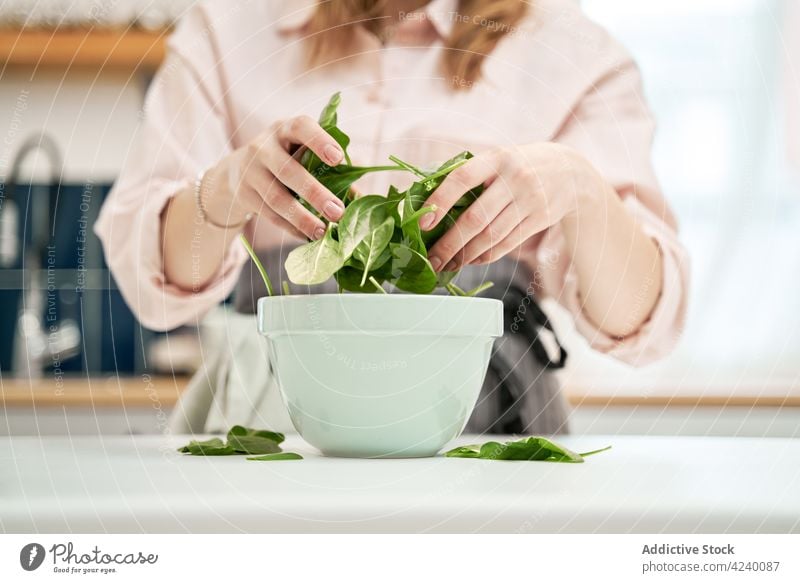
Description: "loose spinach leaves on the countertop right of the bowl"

(444, 436), (611, 464)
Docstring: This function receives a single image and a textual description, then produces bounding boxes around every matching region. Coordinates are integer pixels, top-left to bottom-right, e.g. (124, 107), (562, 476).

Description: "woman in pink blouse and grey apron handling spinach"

(96, 0), (687, 433)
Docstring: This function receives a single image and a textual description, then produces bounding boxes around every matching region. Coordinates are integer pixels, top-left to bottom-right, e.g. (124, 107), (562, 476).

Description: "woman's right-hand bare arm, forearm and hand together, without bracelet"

(420, 144), (663, 338)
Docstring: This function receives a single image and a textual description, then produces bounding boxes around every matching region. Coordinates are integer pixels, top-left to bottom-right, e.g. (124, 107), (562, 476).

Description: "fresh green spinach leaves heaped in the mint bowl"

(242, 93), (492, 296)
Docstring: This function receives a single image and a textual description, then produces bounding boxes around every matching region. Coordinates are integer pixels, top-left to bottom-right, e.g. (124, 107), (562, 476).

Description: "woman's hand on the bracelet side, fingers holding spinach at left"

(202, 115), (344, 239)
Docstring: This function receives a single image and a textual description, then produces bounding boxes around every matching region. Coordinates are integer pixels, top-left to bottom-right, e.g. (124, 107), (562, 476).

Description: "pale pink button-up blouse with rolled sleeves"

(95, 0), (688, 364)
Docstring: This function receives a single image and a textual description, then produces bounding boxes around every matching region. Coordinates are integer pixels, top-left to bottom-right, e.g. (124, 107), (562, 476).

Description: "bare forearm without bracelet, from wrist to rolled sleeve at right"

(562, 163), (663, 337)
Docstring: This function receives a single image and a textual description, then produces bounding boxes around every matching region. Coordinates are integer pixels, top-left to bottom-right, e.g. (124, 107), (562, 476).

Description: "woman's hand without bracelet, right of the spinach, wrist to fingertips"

(420, 143), (597, 271)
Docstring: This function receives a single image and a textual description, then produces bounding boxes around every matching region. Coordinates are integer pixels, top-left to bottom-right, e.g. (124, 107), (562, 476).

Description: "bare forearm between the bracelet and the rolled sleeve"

(161, 176), (241, 291)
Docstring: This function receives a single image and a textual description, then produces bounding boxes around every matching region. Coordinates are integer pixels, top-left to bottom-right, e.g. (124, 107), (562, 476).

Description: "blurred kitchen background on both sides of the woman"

(0, 0), (800, 436)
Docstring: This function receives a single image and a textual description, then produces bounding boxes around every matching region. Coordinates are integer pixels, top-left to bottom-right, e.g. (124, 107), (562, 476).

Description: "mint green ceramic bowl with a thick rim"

(258, 294), (503, 457)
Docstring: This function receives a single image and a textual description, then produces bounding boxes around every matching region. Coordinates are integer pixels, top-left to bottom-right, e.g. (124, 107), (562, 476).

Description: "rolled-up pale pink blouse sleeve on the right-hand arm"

(540, 60), (689, 365)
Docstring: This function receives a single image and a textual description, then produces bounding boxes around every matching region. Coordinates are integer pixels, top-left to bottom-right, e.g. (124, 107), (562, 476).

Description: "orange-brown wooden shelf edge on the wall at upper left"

(0, 29), (168, 71)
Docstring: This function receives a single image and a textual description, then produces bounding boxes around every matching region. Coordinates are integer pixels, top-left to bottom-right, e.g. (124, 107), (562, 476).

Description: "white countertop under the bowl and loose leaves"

(0, 436), (800, 533)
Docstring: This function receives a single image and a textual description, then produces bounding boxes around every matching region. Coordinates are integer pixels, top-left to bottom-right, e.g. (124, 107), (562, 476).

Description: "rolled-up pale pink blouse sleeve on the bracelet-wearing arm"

(94, 10), (246, 330)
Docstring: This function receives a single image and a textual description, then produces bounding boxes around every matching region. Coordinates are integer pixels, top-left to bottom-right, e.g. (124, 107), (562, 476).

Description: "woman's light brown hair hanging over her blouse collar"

(306, 0), (528, 88)
